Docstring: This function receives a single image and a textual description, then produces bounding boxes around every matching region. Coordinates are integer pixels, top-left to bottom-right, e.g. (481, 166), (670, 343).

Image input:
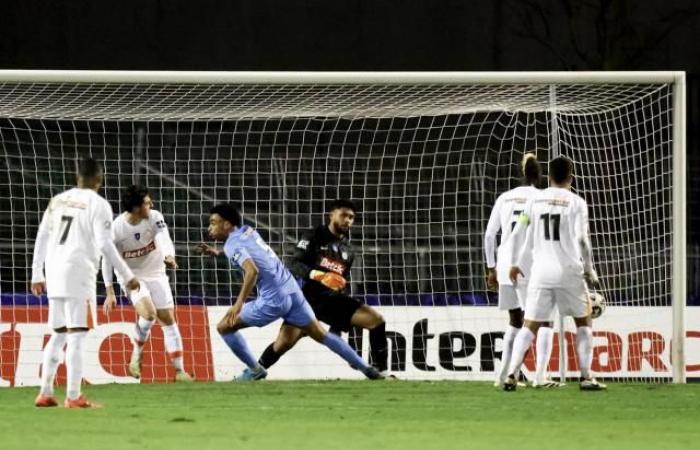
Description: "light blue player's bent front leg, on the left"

(217, 298), (270, 381)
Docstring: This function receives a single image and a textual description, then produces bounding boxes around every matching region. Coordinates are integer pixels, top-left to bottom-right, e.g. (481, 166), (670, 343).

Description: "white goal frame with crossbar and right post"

(0, 70), (687, 383)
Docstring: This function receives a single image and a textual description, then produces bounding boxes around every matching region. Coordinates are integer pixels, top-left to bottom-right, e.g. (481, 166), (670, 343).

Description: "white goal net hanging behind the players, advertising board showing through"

(0, 71), (685, 386)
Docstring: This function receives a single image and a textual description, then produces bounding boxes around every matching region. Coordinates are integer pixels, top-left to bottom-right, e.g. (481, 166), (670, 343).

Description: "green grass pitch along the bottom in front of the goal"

(0, 381), (700, 450)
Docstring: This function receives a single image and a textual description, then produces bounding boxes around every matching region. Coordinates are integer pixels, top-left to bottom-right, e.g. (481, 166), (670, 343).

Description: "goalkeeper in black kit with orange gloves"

(254, 200), (388, 375)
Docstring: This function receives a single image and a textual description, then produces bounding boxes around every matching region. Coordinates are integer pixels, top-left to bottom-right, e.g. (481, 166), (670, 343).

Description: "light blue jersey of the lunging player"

(224, 225), (298, 299)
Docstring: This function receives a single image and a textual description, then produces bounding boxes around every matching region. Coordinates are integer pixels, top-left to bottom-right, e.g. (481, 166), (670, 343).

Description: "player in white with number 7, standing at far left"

(32, 159), (139, 408)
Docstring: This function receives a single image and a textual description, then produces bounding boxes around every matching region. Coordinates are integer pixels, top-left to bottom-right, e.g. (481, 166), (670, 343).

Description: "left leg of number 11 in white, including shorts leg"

(503, 288), (554, 391)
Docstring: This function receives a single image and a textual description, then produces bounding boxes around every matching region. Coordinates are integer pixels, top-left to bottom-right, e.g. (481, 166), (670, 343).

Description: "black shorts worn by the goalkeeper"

(302, 281), (363, 331)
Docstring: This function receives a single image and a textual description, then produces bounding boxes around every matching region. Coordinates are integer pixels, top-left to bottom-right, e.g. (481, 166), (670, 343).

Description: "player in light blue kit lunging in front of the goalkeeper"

(199, 203), (382, 380)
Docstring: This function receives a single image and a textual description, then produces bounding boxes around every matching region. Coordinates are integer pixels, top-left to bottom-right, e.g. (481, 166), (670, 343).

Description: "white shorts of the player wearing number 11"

(525, 282), (591, 322)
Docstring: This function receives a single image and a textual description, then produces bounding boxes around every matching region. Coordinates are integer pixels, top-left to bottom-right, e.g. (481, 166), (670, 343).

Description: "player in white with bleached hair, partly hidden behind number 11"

(484, 153), (559, 388)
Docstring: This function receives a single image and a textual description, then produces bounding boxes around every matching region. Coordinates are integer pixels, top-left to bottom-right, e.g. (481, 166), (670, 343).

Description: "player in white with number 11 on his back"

(503, 156), (606, 391)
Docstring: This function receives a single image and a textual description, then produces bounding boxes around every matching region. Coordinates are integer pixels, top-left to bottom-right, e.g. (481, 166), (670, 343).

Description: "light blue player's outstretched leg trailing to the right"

(285, 291), (383, 380)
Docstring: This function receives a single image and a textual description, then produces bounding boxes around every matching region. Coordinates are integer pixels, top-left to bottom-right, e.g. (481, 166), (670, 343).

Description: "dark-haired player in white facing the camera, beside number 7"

(102, 186), (193, 381)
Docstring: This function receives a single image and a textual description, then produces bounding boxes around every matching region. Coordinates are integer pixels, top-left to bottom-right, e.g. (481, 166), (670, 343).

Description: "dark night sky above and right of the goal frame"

(0, 0), (700, 302)
